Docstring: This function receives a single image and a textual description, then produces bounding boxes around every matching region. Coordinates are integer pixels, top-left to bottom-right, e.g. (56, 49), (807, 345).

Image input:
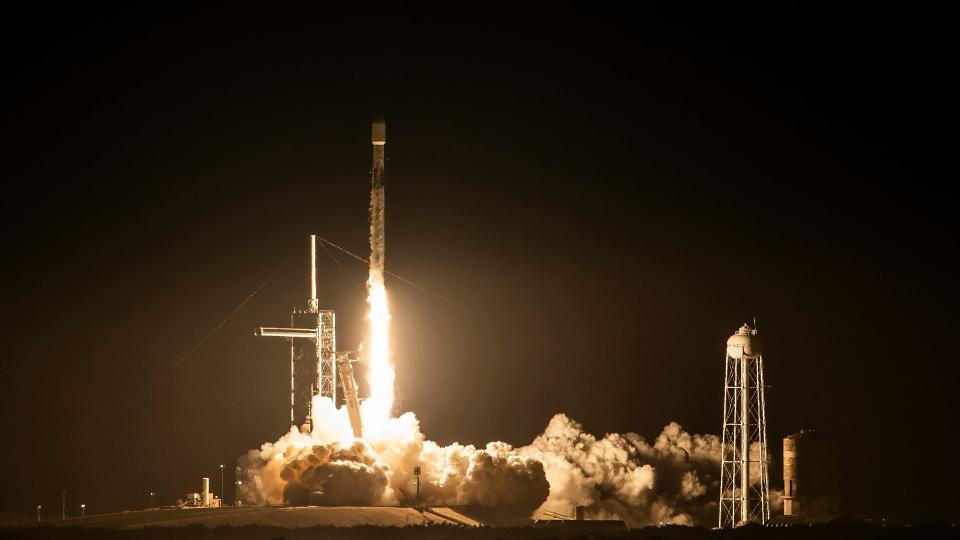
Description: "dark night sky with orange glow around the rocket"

(0, 4), (960, 520)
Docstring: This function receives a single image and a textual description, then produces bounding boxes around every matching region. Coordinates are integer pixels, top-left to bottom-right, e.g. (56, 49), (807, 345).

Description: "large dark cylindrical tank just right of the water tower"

(783, 430), (840, 516)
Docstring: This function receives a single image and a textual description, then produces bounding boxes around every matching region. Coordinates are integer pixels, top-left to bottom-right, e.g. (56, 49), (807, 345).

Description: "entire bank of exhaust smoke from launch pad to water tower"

(241, 402), (777, 527)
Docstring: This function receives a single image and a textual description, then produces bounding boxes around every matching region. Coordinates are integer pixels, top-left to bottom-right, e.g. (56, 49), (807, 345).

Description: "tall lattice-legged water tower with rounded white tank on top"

(719, 324), (770, 528)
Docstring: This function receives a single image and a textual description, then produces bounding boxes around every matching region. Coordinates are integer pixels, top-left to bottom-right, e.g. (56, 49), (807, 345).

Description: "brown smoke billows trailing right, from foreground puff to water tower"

(521, 414), (720, 526)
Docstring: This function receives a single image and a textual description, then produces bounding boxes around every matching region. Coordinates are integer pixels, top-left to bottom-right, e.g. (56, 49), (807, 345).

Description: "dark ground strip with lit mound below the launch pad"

(0, 507), (960, 540)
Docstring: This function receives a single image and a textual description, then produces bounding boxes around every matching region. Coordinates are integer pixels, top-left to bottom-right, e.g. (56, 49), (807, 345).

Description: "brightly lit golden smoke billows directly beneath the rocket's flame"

(240, 404), (550, 522)
